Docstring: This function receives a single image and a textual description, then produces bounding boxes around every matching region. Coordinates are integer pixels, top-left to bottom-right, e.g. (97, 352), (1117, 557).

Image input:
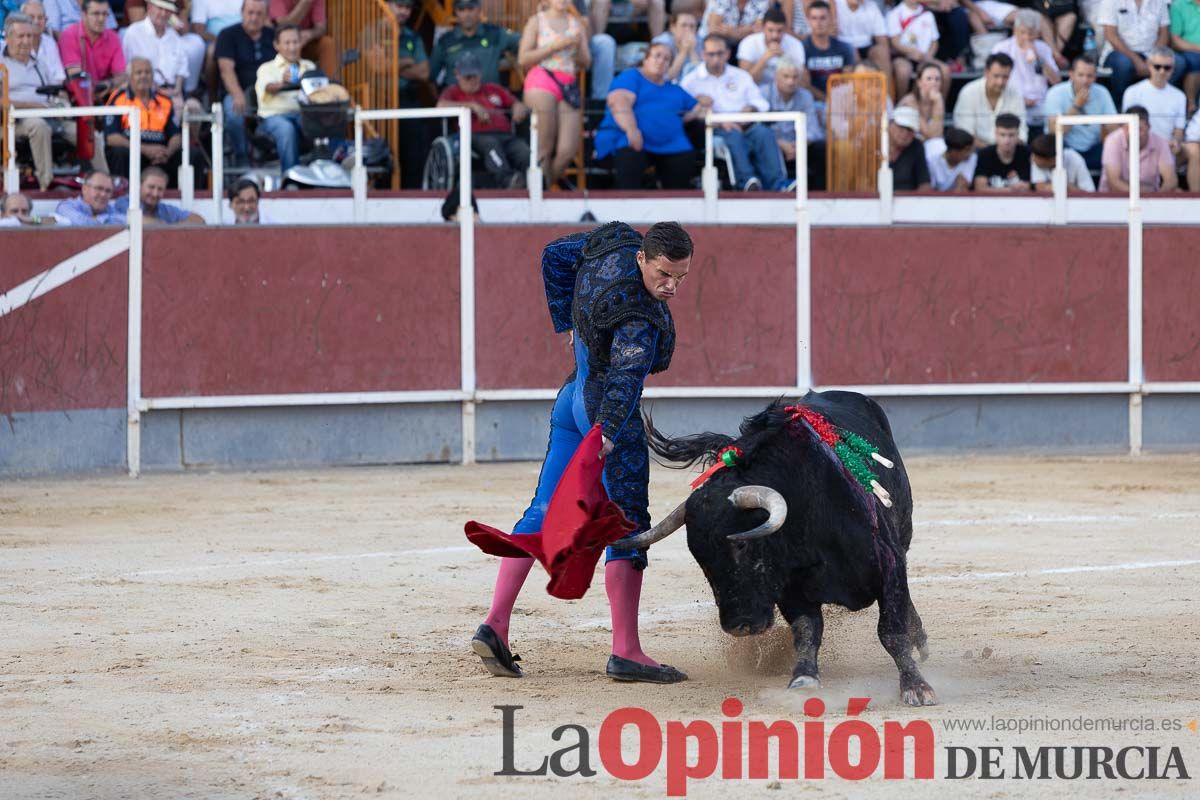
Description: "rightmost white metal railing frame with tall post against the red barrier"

(1052, 114), (1144, 453)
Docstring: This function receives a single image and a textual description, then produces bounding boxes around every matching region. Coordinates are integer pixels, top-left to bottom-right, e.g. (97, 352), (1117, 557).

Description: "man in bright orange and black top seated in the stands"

(104, 55), (204, 181)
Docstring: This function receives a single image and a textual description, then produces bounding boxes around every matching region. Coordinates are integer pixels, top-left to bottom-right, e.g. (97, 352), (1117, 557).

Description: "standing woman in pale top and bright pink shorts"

(517, 0), (592, 186)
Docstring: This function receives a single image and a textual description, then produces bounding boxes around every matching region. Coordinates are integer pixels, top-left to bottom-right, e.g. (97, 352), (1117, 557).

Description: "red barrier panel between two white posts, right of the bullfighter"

(812, 228), (1128, 385)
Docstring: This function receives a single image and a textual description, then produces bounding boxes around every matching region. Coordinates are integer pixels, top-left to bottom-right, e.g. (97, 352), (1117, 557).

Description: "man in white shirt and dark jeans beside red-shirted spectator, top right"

(1096, 0), (1183, 106)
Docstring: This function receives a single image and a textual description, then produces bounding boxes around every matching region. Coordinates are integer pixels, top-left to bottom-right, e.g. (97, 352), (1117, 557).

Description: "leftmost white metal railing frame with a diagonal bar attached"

(5, 106), (142, 476)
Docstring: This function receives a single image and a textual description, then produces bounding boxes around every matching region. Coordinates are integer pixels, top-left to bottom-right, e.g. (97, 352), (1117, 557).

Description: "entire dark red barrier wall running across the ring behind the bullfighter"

(0, 225), (1200, 414)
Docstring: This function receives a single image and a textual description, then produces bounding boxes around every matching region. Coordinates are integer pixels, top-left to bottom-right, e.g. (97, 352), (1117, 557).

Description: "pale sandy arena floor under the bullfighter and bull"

(0, 457), (1200, 800)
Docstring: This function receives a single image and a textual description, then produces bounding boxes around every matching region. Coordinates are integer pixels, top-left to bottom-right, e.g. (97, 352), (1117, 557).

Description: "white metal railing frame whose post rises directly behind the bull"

(701, 112), (812, 386)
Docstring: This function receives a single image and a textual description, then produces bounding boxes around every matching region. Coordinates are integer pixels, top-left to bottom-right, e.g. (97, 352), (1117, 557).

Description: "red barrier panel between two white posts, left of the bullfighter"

(142, 225), (461, 397)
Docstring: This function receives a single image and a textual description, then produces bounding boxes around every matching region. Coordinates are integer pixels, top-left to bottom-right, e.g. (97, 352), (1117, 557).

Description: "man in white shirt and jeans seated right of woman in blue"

(680, 34), (788, 192)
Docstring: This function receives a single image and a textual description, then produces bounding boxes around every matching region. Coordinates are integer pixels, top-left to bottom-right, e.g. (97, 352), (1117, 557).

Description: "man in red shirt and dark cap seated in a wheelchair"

(438, 52), (529, 188)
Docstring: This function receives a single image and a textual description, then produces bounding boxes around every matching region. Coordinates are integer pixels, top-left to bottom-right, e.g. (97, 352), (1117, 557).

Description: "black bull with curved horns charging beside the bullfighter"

(623, 391), (937, 705)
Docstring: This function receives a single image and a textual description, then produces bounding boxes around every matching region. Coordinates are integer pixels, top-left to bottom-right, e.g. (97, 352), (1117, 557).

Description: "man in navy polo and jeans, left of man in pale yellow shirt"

(216, 0), (275, 167)
